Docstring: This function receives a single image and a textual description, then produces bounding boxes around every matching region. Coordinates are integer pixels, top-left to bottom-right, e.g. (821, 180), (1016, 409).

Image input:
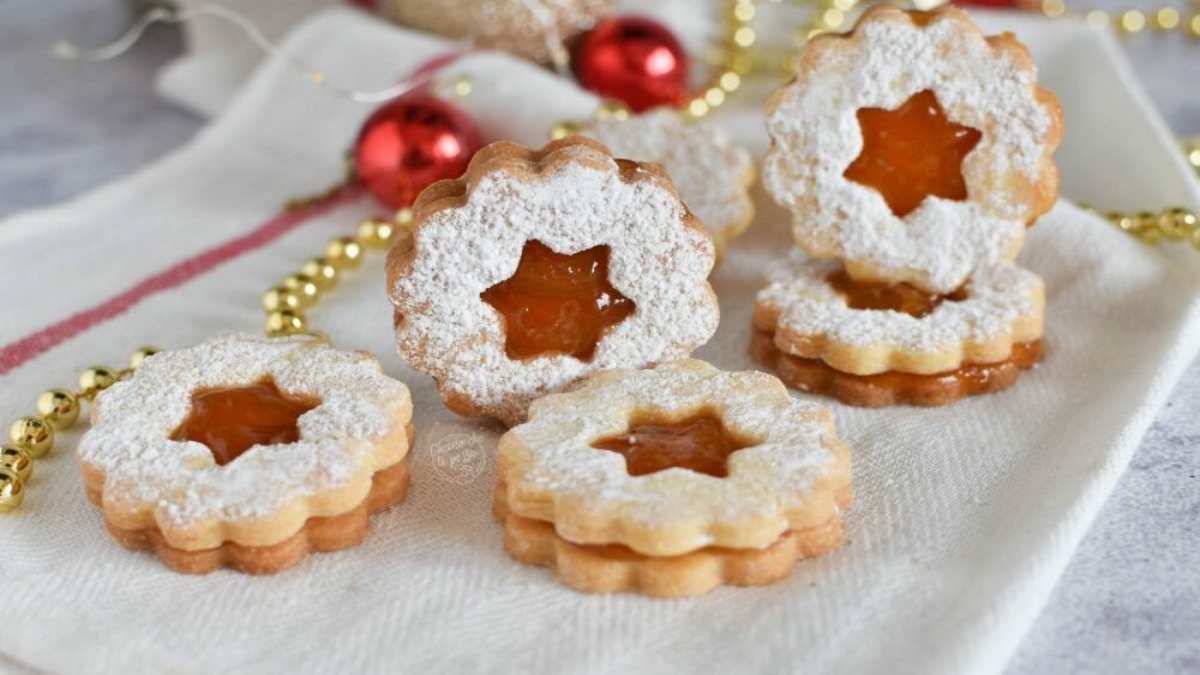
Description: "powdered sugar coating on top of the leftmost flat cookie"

(78, 335), (412, 527)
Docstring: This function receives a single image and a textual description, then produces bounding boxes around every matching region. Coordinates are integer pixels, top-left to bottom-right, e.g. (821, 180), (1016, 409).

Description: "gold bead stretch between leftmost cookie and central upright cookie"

(263, 209), (413, 336)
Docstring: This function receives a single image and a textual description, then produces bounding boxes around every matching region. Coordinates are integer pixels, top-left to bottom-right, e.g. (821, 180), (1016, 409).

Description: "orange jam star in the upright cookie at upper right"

(842, 89), (983, 217)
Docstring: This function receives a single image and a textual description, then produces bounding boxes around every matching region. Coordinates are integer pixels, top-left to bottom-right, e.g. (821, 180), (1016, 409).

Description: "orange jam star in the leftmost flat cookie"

(170, 380), (319, 466)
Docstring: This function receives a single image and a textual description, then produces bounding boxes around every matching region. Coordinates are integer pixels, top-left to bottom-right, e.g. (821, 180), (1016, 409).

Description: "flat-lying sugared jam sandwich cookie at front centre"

(494, 359), (852, 597)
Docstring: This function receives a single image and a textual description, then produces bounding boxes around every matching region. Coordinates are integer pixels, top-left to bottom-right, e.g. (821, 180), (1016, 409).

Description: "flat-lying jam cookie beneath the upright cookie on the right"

(751, 252), (1045, 407)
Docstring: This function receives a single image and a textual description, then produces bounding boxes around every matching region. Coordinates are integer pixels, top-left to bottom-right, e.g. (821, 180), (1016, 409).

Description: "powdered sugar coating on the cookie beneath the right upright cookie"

(755, 251), (1044, 370)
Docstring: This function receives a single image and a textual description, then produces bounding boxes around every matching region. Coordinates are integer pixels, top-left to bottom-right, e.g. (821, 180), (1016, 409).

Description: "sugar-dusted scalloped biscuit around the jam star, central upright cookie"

(389, 138), (719, 424)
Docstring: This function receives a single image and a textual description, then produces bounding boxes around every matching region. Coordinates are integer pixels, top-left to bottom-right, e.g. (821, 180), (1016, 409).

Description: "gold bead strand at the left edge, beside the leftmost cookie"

(0, 347), (158, 513)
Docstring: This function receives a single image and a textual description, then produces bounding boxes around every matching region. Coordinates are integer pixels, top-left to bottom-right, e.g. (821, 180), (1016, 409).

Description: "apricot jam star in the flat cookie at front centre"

(592, 412), (754, 478)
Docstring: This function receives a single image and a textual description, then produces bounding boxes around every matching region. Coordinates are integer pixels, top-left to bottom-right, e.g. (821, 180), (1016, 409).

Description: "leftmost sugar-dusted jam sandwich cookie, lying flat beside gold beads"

(78, 335), (413, 574)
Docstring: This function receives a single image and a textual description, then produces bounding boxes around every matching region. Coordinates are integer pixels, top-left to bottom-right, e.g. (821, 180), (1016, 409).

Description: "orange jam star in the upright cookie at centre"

(480, 240), (635, 360)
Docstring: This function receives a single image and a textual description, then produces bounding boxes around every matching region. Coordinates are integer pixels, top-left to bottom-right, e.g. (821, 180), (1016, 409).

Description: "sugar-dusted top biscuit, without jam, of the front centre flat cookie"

(499, 359), (848, 555)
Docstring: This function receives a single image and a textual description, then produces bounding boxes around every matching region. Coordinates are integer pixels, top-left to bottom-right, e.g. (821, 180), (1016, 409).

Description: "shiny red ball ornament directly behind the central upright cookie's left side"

(354, 94), (482, 209)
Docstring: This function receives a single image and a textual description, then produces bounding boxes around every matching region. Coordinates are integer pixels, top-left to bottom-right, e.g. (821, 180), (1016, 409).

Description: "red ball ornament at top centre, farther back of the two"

(571, 17), (689, 113)
